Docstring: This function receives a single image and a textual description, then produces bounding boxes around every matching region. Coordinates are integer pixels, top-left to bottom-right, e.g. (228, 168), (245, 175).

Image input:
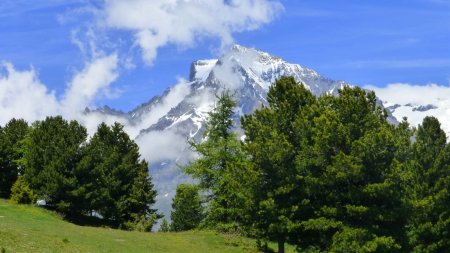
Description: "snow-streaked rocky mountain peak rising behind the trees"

(88, 45), (380, 219)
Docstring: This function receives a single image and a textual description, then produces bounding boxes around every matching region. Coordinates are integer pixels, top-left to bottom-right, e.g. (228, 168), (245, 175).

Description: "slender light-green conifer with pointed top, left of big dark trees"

(184, 91), (252, 229)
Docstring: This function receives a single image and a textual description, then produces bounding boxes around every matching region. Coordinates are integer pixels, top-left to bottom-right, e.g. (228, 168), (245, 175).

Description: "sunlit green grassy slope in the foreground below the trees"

(0, 199), (294, 253)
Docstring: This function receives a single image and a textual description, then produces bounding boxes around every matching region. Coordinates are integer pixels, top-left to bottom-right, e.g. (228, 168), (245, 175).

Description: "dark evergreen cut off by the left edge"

(0, 119), (28, 198)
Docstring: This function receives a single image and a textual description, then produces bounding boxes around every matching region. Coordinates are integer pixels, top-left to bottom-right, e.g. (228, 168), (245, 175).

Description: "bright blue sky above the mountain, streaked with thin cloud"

(0, 0), (450, 111)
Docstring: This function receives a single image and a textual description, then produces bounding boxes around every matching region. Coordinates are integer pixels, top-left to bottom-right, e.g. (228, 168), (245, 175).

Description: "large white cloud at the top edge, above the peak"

(100, 0), (283, 64)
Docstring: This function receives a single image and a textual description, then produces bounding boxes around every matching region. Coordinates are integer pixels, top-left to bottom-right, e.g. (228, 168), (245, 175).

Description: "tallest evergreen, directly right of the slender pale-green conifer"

(242, 77), (315, 253)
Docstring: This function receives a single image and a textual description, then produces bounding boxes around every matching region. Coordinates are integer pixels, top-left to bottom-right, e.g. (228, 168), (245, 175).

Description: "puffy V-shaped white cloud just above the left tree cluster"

(0, 54), (118, 125)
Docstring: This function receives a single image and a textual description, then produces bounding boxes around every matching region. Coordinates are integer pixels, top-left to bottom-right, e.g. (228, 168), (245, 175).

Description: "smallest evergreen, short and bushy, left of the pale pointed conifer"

(171, 184), (203, 232)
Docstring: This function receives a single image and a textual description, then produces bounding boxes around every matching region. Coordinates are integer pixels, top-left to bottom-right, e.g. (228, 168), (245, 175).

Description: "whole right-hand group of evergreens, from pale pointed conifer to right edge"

(176, 77), (450, 252)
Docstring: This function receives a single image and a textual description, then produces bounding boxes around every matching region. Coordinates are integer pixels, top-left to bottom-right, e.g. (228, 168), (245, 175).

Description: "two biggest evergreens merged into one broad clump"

(242, 78), (410, 252)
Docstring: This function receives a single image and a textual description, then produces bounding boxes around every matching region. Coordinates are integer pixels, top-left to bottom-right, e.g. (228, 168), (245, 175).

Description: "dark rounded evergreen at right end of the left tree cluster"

(76, 123), (160, 231)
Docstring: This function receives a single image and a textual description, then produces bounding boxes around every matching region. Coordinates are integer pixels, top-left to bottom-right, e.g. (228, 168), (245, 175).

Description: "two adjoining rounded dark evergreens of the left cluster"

(12, 116), (160, 231)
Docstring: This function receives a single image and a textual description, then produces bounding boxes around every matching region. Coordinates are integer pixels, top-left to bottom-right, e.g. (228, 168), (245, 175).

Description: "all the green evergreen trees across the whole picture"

(0, 77), (450, 253)
